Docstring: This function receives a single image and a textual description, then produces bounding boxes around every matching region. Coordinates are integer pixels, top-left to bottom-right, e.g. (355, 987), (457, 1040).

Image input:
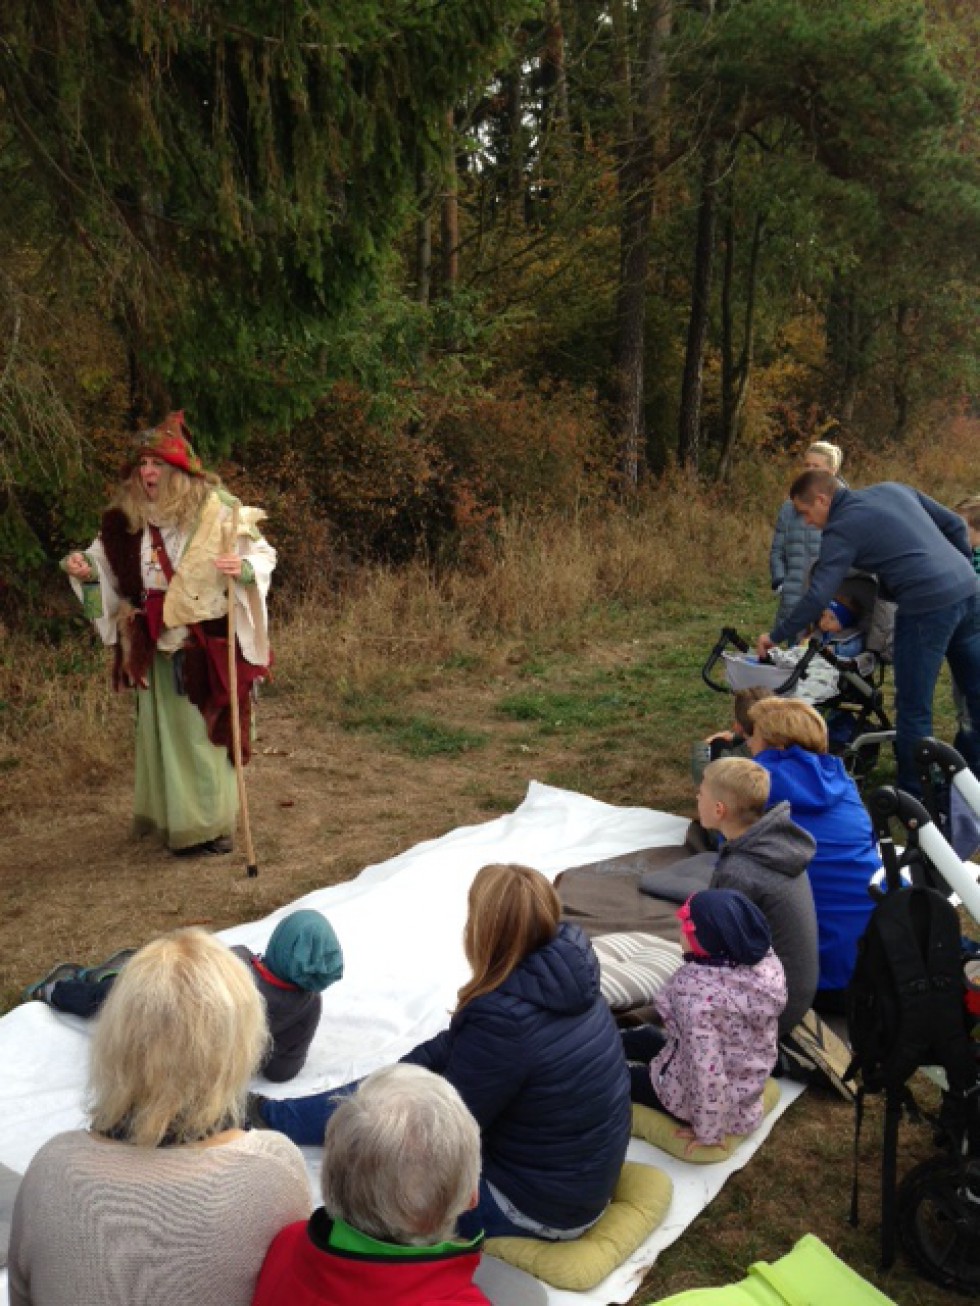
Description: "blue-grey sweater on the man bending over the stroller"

(771, 481), (977, 644)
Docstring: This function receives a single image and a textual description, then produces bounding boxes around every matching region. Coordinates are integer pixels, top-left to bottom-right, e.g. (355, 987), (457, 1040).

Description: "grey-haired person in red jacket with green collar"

(252, 1066), (487, 1306)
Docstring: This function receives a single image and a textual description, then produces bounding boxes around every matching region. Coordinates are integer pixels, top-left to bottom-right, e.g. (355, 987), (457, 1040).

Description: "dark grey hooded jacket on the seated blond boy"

(711, 802), (819, 1034)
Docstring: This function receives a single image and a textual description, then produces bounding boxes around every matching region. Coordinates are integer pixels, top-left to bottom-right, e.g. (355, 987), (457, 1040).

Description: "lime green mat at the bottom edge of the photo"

(645, 1233), (895, 1306)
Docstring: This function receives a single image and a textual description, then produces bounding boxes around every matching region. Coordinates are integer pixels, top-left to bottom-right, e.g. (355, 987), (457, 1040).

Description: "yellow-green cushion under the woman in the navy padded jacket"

(485, 1161), (673, 1293)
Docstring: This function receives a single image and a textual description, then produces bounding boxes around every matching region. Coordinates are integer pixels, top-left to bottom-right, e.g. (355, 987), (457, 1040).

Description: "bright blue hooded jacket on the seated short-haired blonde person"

(755, 744), (881, 991)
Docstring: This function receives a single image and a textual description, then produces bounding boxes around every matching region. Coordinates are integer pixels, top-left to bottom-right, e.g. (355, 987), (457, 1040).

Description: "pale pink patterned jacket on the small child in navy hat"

(649, 952), (787, 1144)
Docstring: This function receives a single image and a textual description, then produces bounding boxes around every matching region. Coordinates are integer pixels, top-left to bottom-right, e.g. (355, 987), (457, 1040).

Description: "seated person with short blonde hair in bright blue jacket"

(749, 697), (881, 1013)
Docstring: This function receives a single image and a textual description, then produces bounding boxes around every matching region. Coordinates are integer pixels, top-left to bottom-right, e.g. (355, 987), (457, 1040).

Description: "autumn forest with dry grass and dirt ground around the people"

(0, 0), (980, 1306)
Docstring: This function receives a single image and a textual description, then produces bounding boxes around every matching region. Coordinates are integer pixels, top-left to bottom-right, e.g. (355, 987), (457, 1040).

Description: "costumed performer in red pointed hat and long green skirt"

(63, 413), (276, 854)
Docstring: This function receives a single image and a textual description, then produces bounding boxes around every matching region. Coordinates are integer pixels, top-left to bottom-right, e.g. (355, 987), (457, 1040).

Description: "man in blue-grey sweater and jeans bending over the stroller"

(757, 471), (980, 794)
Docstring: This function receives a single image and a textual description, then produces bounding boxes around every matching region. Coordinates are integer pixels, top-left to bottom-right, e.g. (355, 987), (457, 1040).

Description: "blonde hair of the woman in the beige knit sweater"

(90, 929), (269, 1147)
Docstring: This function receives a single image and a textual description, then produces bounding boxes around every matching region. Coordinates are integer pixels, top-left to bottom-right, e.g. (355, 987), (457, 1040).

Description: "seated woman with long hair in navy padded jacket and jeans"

(252, 865), (630, 1241)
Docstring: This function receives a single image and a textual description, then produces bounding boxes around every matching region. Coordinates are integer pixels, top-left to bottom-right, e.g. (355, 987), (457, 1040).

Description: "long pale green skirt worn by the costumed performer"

(133, 653), (238, 852)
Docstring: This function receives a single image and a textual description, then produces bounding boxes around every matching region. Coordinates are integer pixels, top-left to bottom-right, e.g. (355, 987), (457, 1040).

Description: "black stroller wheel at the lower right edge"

(898, 1155), (980, 1297)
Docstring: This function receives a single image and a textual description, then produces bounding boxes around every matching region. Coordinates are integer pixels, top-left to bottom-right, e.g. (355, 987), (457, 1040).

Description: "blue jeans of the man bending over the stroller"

(894, 594), (980, 797)
